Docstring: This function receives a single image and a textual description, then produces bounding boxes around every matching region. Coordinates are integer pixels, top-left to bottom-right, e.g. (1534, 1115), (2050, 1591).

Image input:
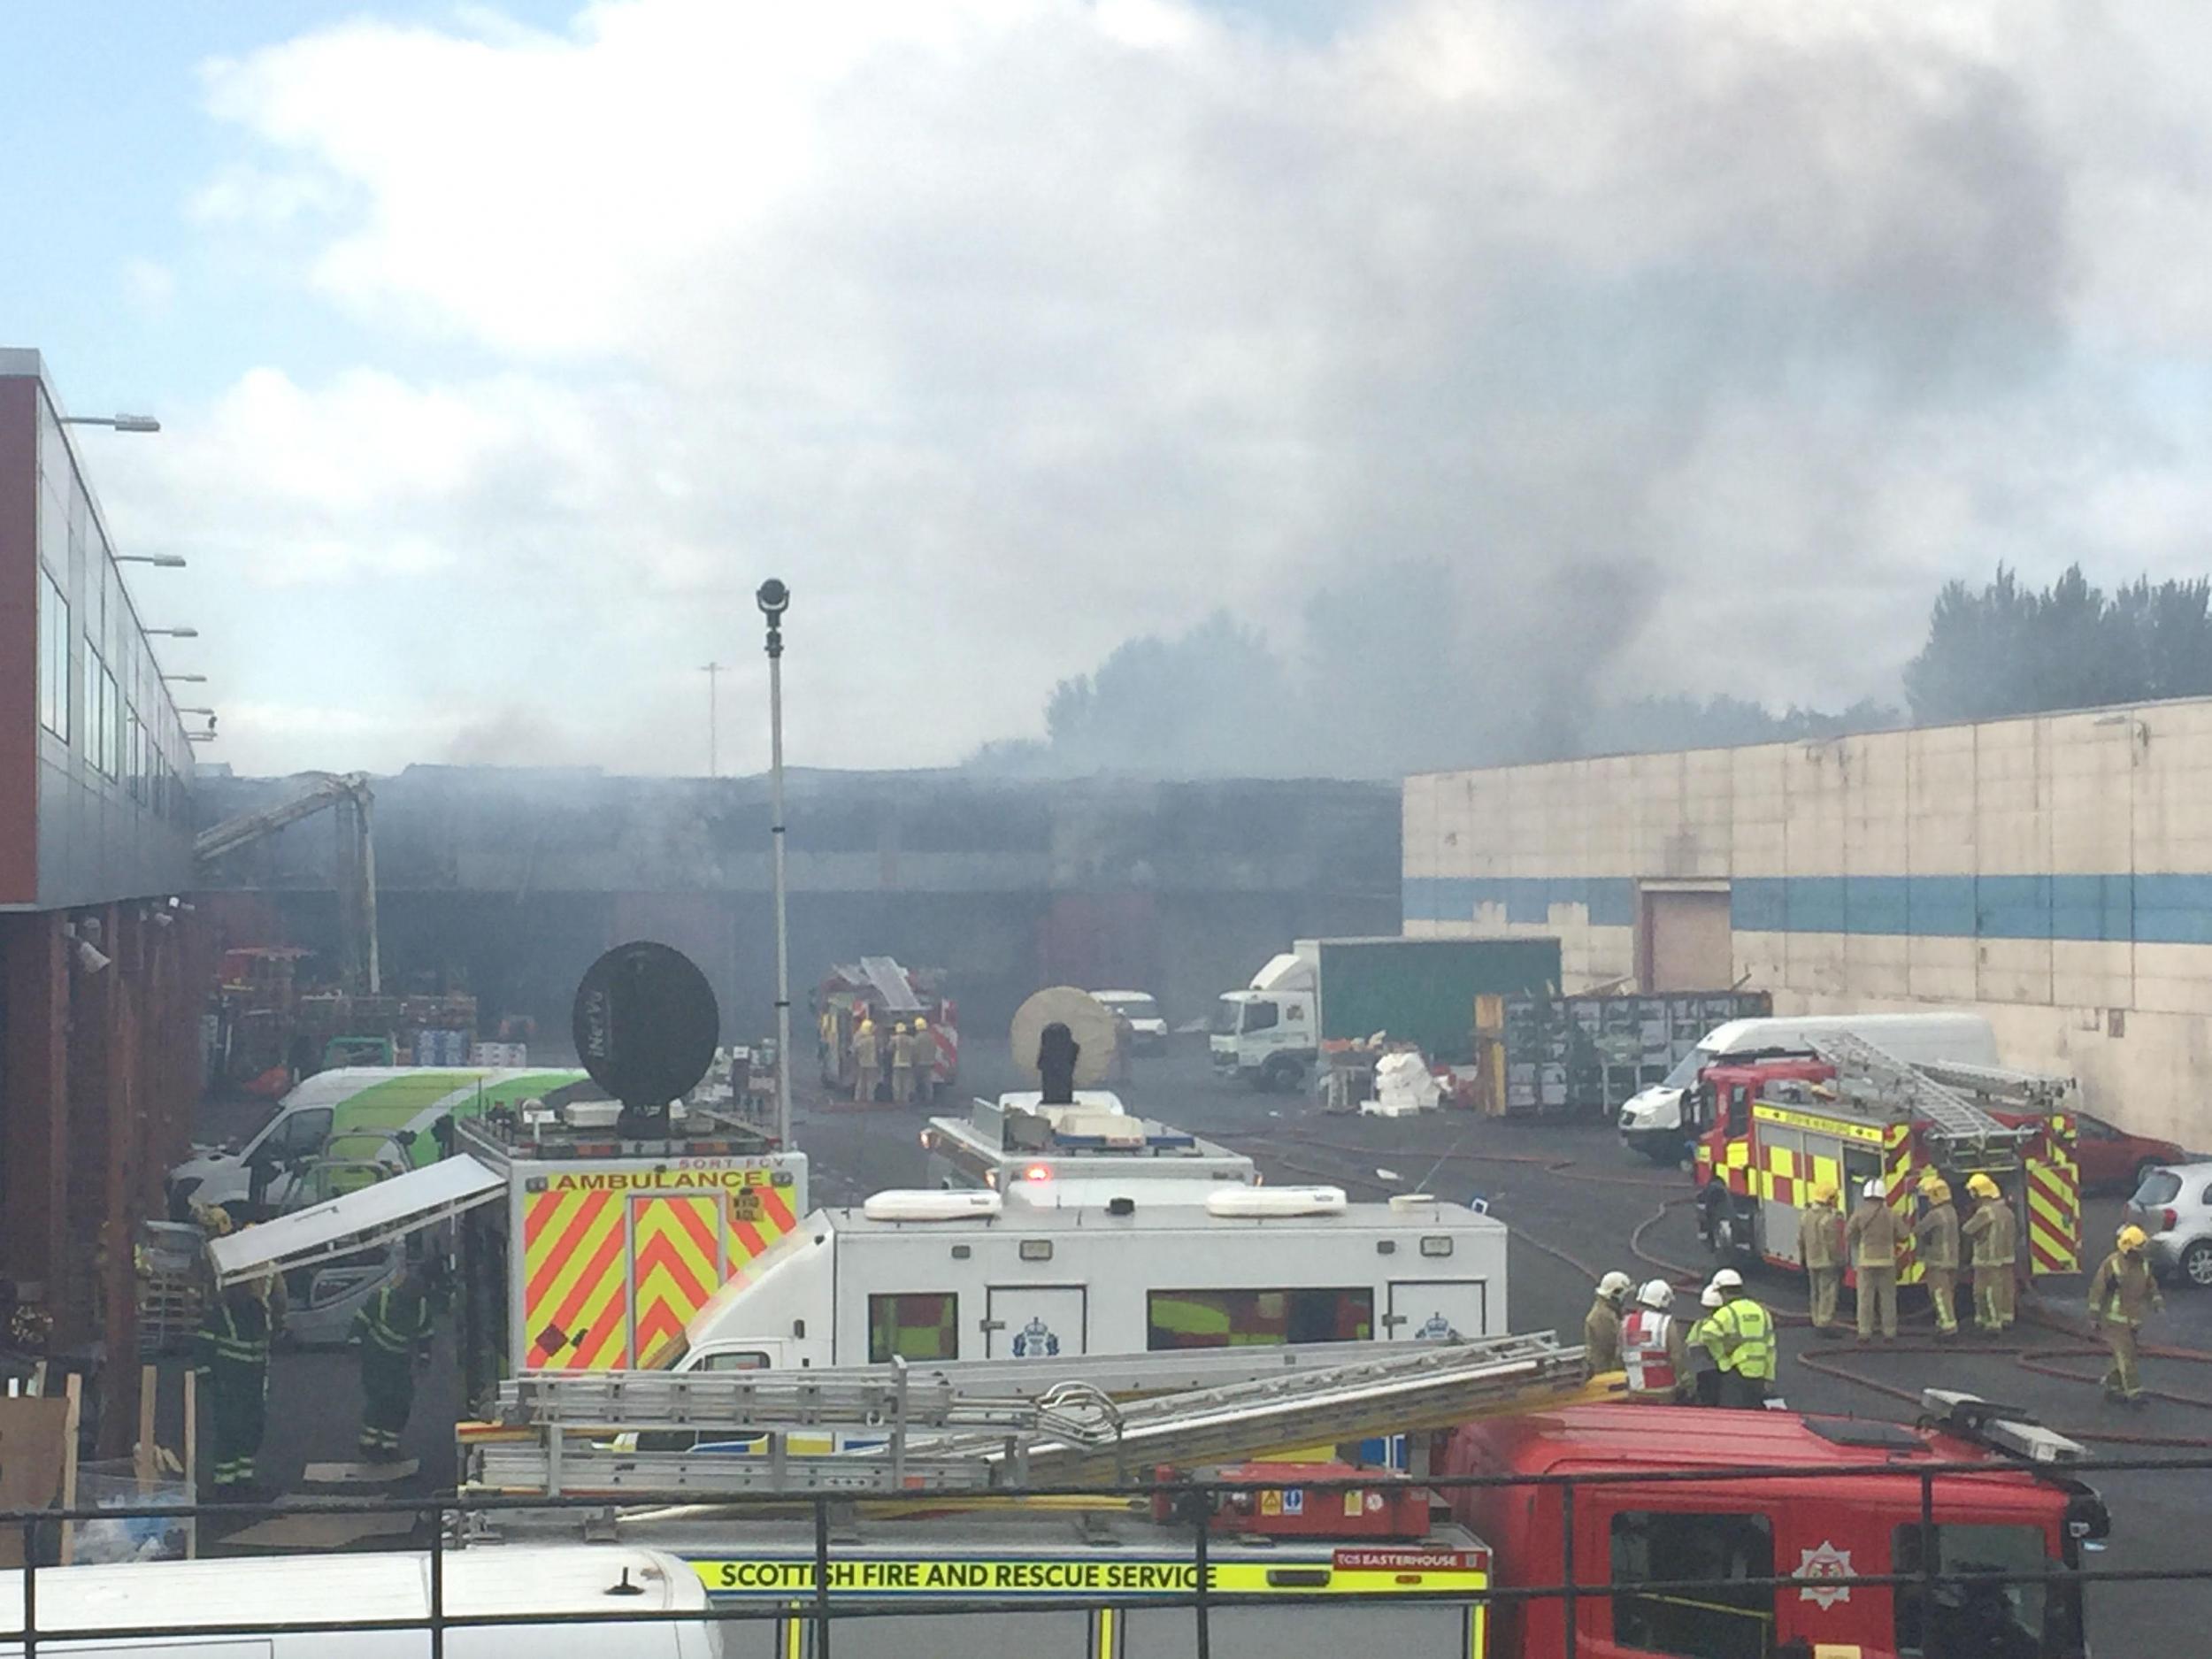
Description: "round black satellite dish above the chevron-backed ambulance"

(573, 941), (721, 1113)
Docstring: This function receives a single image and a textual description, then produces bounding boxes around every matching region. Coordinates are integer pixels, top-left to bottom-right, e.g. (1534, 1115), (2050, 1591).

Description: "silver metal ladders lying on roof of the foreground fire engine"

(463, 1334), (1582, 1502)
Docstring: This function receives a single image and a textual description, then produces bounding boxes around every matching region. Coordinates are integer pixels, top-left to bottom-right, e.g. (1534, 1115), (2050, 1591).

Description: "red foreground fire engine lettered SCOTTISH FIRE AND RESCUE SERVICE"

(463, 1334), (2108, 1659)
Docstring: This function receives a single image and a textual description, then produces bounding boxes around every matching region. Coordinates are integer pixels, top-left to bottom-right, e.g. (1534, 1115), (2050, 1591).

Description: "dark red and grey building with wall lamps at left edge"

(0, 349), (208, 1454)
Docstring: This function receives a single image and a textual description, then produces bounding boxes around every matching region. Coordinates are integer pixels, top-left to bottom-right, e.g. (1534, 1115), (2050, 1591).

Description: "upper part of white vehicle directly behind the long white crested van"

(923, 1088), (1259, 1190)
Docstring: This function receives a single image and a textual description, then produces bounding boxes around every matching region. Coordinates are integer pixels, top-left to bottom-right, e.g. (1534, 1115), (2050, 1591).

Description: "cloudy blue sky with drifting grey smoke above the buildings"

(12, 0), (2212, 772)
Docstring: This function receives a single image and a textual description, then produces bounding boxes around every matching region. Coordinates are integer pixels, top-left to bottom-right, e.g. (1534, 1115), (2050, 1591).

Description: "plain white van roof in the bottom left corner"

(0, 1544), (724, 1659)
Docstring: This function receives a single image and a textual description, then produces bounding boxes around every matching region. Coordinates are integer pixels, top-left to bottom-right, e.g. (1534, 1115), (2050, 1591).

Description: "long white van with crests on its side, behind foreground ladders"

(650, 1179), (1507, 1371)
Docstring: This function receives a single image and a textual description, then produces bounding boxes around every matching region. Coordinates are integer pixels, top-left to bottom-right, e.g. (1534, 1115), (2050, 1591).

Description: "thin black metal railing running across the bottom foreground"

(0, 1449), (2212, 1659)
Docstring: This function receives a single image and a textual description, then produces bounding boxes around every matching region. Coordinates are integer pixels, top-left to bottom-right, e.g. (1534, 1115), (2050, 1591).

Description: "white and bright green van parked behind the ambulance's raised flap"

(168, 1066), (600, 1221)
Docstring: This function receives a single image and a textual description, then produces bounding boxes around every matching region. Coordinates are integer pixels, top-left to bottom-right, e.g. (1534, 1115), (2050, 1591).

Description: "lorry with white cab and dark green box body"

(1210, 938), (1560, 1091)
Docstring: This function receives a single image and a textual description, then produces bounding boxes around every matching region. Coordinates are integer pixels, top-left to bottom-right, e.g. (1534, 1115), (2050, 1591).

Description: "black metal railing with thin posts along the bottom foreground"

(0, 1451), (2212, 1659)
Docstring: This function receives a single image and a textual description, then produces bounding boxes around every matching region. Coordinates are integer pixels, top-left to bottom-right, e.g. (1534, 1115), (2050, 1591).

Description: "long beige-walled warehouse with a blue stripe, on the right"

(1402, 699), (2212, 1146)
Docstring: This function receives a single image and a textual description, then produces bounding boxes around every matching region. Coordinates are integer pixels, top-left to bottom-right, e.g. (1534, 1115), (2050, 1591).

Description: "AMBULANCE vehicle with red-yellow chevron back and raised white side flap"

(208, 1102), (808, 1394)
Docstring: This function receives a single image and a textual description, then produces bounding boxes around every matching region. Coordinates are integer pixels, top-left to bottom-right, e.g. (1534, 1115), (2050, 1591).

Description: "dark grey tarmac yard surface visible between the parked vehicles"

(199, 1038), (2212, 1655)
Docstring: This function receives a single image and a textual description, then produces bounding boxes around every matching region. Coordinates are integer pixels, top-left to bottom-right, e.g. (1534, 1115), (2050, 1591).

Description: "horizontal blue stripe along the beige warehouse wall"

(1405, 876), (2212, 945)
